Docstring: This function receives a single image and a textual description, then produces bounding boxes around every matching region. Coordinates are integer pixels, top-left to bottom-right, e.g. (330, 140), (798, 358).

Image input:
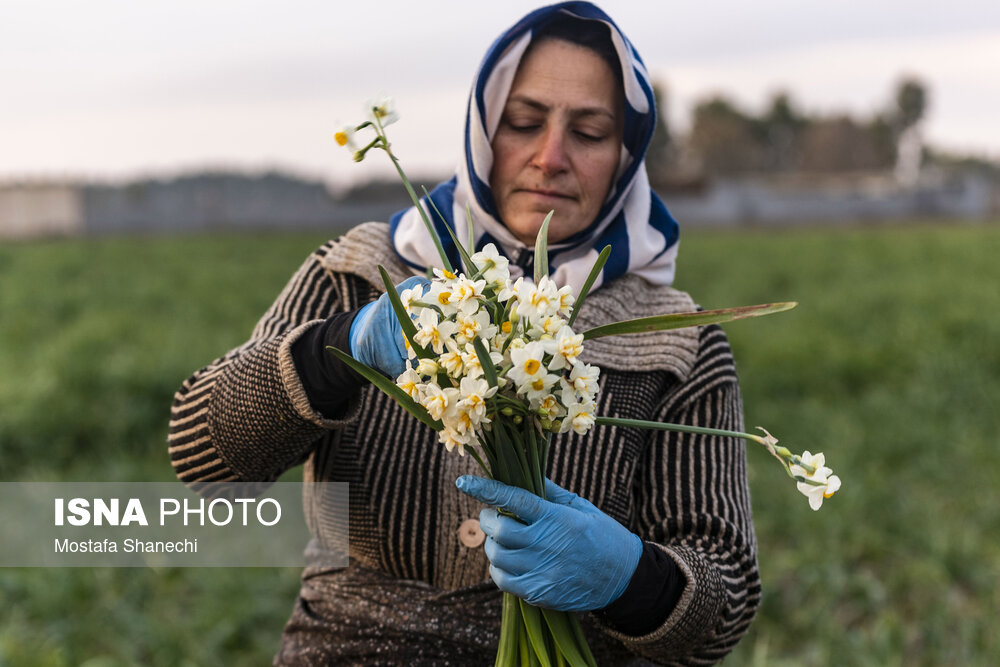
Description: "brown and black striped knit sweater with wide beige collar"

(169, 223), (760, 665)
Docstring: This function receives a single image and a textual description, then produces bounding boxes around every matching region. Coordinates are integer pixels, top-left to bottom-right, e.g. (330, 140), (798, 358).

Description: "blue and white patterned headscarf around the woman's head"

(390, 2), (679, 292)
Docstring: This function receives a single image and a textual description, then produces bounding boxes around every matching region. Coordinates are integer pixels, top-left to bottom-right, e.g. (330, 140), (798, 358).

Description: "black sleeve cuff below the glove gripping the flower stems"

(595, 542), (687, 637)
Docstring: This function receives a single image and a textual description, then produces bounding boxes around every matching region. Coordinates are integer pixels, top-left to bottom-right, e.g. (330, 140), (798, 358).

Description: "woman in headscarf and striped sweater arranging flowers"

(170, 2), (760, 665)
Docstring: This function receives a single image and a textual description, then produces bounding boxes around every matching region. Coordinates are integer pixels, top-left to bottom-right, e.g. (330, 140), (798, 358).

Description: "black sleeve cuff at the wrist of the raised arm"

(292, 310), (366, 419)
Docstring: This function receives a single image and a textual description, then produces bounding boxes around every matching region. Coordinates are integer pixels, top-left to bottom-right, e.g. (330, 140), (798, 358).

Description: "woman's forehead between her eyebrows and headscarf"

(508, 39), (622, 115)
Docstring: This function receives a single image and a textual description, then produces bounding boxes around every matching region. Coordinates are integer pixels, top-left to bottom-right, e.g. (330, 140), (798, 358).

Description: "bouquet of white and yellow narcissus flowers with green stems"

(330, 100), (840, 665)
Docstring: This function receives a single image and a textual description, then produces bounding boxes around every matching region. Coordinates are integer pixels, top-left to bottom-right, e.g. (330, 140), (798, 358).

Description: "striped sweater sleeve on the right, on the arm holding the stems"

(592, 326), (761, 665)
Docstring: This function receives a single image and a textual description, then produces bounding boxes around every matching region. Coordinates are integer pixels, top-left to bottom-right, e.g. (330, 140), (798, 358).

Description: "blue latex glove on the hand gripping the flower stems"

(456, 475), (642, 611)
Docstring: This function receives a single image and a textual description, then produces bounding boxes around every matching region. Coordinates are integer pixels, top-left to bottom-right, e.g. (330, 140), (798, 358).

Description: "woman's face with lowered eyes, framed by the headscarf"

(490, 40), (624, 246)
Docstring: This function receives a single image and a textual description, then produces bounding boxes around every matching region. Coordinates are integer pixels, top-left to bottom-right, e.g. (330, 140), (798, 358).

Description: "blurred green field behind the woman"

(0, 225), (1000, 667)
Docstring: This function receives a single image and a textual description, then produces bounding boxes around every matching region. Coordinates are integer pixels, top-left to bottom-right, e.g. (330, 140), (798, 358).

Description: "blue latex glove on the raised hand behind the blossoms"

(349, 276), (430, 378)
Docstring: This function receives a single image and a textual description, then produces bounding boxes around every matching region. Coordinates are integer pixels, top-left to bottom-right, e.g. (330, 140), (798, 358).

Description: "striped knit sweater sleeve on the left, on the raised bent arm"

(168, 242), (368, 483)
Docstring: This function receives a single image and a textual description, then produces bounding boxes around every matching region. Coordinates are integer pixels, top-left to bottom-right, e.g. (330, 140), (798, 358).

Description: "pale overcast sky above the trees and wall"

(0, 0), (1000, 185)
